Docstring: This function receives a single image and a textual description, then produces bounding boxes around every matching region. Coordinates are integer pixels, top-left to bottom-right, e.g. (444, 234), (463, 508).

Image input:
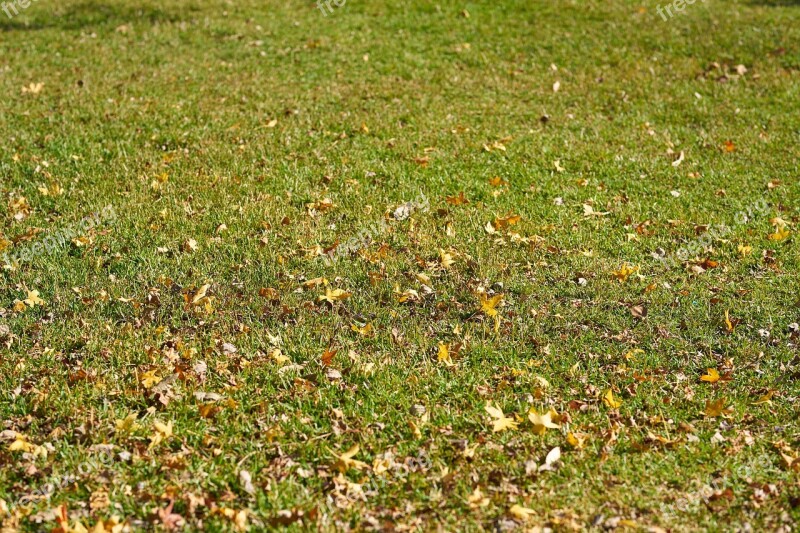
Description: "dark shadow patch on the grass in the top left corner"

(0, 0), (198, 32)
